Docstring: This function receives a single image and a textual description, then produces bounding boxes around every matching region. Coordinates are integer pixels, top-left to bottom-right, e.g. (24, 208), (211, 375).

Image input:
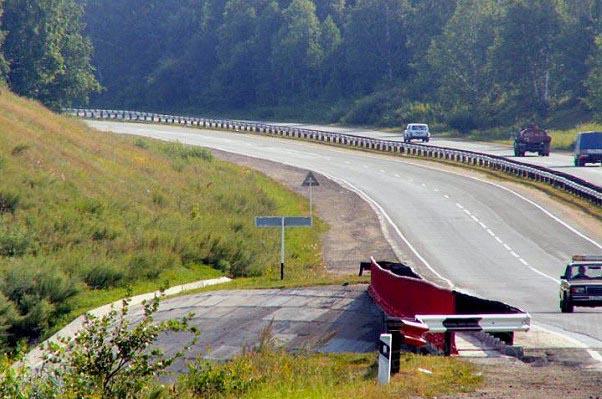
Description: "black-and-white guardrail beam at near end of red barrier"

(416, 313), (531, 333)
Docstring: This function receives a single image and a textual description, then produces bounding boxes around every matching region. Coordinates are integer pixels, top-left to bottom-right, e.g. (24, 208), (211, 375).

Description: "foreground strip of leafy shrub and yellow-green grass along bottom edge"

(0, 297), (482, 399)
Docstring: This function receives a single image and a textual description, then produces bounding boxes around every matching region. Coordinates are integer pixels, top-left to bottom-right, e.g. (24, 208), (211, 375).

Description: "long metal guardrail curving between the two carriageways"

(63, 108), (602, 206)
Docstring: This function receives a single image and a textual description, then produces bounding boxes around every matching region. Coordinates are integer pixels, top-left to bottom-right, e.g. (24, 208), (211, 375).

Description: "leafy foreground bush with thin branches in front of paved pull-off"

(45, 297), (199, 398)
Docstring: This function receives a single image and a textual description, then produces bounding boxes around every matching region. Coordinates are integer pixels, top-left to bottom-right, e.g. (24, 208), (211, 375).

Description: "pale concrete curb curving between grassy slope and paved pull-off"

(22, 277), (232, 369)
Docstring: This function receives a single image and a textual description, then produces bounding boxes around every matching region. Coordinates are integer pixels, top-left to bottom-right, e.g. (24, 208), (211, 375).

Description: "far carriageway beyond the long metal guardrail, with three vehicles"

(270, 122), (602, 186)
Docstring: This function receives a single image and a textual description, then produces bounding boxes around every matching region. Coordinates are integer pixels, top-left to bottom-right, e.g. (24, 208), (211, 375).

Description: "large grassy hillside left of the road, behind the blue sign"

(0, 90), (327, 345)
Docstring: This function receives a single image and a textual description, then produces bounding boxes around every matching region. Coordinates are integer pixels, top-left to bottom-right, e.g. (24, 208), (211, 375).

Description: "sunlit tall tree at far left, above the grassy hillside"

(2, 0), (100, 108)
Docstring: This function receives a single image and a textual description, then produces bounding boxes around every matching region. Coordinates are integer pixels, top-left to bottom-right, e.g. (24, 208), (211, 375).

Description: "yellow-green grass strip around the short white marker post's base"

(173, 350), (482, 399)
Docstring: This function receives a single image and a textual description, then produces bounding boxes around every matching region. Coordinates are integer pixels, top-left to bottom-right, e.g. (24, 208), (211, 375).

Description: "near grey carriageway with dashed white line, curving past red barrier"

(89, 121), (602, 361)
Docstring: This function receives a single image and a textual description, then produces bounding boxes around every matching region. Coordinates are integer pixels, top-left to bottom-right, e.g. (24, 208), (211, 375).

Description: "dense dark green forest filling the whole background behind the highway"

(0, 0), (602, 132)
